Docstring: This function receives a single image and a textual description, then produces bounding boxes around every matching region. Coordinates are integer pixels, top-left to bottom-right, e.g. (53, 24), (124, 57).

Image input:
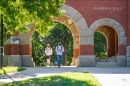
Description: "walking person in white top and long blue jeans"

(56, 42), (64, 68)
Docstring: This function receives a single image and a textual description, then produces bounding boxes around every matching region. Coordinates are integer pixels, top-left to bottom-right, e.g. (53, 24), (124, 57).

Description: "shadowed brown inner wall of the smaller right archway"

(96, 25), (118, 60)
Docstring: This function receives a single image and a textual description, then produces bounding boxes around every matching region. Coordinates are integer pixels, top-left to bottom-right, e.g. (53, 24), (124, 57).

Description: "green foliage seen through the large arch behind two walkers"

(32, 23), (73, 66)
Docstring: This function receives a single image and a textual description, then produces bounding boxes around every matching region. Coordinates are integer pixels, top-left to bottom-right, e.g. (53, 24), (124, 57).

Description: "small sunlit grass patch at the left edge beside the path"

(0, 67), (26, 75)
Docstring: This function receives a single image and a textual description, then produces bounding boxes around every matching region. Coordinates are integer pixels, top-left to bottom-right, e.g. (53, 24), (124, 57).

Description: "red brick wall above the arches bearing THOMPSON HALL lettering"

(66, 0), (127, 35)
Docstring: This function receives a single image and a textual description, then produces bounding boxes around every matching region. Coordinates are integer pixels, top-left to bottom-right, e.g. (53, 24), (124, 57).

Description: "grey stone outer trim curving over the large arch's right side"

(60, 4), (91, 45)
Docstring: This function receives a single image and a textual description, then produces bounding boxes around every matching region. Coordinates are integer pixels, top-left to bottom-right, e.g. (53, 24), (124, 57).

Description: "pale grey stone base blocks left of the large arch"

(3, 55), (35, 67)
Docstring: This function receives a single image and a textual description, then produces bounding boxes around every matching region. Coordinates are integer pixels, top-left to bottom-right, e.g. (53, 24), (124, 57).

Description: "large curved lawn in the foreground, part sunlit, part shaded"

(0, 72), (101, 86)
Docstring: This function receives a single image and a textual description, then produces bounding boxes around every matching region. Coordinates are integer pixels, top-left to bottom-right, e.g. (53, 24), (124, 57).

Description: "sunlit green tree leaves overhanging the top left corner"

(0, 0), (65, 35)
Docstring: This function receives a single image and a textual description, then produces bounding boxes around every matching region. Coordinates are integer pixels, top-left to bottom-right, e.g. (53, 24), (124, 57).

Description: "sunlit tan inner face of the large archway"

(30, 15), (79, 66)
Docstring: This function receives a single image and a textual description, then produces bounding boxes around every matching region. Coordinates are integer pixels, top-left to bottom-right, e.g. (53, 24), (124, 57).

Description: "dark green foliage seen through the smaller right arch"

(94, 32), (107, 59)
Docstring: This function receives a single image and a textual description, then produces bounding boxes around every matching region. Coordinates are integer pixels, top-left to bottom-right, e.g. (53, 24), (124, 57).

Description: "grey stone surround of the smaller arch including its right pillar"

(89, 18), (127, 66)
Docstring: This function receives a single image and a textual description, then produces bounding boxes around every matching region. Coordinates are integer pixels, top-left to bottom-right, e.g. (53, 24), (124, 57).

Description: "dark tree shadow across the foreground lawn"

(1, 76), (94, 86)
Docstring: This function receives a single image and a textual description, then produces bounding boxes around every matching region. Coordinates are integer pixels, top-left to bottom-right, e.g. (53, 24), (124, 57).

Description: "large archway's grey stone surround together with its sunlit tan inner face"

(29, 4), (88, 65)
